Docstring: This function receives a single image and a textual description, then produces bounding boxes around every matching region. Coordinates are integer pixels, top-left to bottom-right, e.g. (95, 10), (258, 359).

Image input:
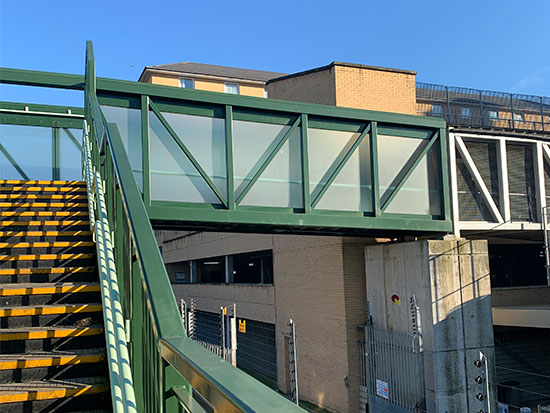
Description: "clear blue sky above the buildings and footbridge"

(0, 0), (550, 106)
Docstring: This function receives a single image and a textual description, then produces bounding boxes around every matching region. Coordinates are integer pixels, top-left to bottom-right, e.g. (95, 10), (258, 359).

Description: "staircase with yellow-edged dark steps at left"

(0, 180), (111, 413)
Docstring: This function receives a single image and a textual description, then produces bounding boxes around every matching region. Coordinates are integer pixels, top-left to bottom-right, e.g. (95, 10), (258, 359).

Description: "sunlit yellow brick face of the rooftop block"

(335, 65), (416, 115)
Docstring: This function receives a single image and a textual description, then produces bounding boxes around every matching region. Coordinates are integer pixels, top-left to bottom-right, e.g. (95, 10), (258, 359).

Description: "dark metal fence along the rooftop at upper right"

(416, 82), (550, 133)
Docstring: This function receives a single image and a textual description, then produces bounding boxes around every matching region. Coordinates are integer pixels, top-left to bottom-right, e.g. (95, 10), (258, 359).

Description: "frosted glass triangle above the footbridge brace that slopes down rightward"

(162, 112), (227, 196)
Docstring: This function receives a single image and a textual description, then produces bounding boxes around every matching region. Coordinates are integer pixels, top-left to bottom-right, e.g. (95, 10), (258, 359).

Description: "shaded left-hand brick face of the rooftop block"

(267, 68), (336, 106)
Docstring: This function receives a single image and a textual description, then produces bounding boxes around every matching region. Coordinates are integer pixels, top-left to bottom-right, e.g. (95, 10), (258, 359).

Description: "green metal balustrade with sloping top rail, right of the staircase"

(85, 43), (303, 413)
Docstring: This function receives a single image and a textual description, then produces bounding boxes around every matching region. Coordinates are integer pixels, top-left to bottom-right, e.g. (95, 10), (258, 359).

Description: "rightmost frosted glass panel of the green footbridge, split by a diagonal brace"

(378, 135), (441, 215)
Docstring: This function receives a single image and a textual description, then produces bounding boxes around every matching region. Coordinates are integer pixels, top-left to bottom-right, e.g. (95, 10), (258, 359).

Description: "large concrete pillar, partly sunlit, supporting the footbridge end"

(365, 238), (497, 413)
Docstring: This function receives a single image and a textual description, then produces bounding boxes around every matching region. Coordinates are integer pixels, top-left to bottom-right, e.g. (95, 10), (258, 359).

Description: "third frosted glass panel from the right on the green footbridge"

(233, 121), (303, 208)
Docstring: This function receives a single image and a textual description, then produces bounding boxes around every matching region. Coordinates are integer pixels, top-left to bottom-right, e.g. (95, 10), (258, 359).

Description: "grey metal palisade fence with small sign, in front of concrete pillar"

(359, 325), (426, 412)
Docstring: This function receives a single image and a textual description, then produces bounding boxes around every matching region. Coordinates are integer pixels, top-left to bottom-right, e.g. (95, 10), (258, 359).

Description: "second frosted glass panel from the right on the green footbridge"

(308, 129), (372, 211)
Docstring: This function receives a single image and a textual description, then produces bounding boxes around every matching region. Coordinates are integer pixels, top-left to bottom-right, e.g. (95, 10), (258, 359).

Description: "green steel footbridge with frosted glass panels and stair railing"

(0, 42), (453, 413)
